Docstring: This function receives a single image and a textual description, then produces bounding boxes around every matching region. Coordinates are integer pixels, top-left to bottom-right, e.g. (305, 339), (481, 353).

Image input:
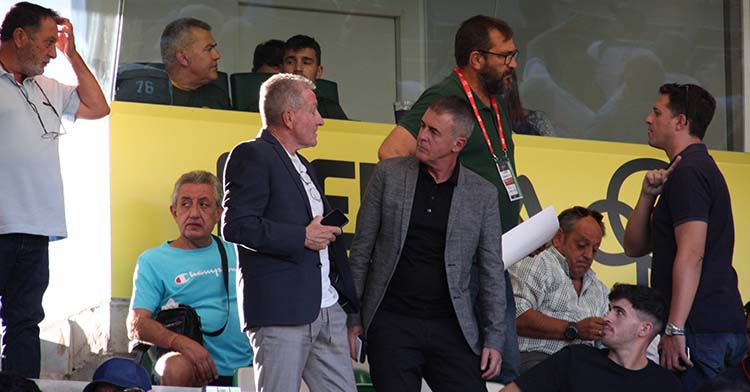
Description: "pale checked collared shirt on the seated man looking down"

(508, 246), (609, 354)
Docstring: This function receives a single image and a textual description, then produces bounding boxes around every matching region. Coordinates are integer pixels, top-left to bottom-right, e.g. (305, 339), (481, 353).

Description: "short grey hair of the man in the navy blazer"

(259, 73), (315, 127)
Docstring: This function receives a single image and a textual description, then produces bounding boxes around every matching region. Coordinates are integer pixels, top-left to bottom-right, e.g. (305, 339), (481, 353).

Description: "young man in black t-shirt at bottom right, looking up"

(503, 284), (682, 392)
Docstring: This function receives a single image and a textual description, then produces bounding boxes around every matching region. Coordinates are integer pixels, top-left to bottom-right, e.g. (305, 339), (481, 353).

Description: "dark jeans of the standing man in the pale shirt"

(0, 234), (49, 378)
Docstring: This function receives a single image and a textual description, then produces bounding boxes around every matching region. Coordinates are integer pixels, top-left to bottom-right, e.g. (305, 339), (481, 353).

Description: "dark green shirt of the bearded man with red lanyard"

(399, 72), (521, 232)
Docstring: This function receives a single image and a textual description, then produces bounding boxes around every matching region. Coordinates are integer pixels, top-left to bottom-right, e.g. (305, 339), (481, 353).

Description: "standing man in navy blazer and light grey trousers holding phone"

(223, 74), (357, 392)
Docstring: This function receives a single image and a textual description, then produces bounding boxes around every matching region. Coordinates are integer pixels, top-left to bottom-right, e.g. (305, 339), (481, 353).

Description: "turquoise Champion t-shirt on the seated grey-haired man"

(130, 237), (253, 376)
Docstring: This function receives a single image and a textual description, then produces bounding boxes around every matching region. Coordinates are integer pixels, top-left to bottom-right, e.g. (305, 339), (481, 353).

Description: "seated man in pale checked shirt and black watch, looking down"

(509, 207), (609, 373)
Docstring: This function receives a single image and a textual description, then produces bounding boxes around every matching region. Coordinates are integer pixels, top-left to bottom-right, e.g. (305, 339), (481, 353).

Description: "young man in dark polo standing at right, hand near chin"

(623, 84), (747, 391)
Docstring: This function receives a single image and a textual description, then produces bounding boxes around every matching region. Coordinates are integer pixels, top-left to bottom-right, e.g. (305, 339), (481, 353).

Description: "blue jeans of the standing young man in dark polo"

(677, 331), (747, 392)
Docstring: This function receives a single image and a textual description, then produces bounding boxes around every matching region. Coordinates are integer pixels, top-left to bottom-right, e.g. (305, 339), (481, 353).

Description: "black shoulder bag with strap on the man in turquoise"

(155, 234), (229, 355)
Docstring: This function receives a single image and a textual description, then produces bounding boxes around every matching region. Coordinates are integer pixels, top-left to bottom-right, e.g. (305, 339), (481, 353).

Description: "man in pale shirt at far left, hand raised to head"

(0, 2), (109, 378)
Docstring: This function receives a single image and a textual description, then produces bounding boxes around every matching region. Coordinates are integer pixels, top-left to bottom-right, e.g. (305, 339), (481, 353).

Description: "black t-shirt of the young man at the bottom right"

(515, 345), (683, 392)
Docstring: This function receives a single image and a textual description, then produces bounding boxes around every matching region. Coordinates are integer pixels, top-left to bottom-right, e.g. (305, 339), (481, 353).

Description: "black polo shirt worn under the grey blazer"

(380, 163), (460, 319)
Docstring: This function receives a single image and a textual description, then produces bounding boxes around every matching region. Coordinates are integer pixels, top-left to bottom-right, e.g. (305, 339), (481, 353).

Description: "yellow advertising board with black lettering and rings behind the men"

(110, 102), (750, 300)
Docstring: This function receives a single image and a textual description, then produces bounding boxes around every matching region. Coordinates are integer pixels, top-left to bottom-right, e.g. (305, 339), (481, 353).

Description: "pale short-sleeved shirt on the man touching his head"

(0, 67), (81, 239)
